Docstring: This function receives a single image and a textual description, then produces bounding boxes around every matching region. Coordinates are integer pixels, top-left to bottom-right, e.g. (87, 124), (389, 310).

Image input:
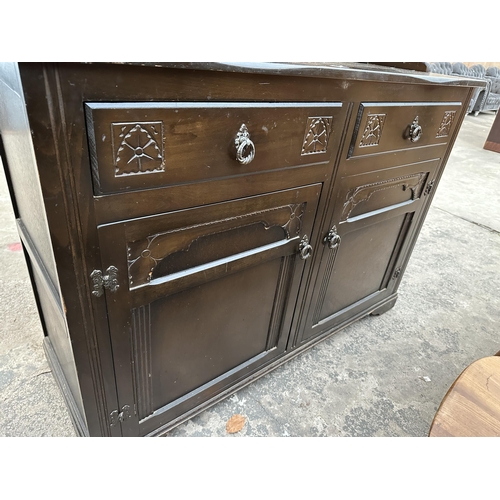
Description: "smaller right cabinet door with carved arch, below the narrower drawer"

(298, 160), (439, 343)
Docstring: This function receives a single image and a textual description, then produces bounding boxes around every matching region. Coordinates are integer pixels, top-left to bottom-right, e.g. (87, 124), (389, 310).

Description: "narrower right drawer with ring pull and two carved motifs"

(348, 102), (462, 158)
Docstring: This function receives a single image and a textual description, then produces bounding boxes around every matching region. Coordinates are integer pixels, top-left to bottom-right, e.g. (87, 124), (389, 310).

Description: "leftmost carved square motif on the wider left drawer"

(111, 122), (165, 177)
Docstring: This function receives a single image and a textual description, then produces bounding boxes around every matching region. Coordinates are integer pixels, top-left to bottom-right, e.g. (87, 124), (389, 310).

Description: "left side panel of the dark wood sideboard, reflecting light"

(0, 63), (83, 430)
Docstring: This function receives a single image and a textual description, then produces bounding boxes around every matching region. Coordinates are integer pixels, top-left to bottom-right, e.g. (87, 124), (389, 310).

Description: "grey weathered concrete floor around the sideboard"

(0, 114), (500, 437)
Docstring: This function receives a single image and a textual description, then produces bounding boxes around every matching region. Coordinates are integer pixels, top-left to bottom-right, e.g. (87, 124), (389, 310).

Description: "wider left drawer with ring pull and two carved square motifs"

(86, 102), (343, 195)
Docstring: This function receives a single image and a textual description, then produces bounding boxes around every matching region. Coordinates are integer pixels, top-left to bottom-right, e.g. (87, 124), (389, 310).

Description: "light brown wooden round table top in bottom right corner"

(429, 356), (500, 437)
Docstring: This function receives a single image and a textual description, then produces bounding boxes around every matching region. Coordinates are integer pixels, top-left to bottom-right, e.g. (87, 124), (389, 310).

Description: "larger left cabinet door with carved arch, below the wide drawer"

(98, 184), (321, 435)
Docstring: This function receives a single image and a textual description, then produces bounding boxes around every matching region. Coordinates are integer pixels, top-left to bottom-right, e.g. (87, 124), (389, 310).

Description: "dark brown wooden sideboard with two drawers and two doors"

(0, 63), (482, 436)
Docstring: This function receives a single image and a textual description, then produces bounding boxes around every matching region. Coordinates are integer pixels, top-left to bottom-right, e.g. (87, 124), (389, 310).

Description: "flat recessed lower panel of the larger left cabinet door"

(147, 259), (282, 417)
